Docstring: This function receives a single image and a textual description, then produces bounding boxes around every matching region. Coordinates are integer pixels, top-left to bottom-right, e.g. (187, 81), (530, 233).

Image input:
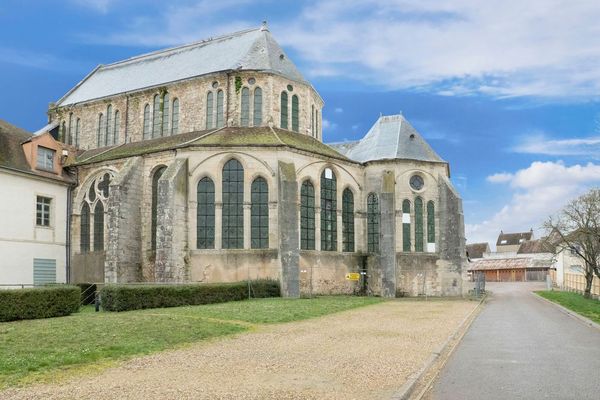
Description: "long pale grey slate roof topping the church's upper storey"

(57, 25), (305, 106)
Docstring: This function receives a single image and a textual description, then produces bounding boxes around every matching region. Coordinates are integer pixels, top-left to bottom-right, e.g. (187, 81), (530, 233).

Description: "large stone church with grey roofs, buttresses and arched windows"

(46, 25), (466, 297)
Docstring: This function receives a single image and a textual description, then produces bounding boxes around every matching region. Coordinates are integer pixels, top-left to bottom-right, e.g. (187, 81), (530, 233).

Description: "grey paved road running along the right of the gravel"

(432, 283), (600, 400)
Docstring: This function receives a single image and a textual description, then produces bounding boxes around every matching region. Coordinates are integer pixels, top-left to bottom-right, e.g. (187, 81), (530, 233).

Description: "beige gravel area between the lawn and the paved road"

(0, 300), (477, 399)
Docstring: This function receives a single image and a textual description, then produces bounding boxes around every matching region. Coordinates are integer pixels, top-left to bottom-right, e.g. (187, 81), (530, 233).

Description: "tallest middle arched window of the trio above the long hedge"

(221, 159), (244, 249)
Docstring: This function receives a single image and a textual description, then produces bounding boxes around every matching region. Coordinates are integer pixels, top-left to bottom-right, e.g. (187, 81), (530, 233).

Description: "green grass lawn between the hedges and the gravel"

(0, 296), (381, 389)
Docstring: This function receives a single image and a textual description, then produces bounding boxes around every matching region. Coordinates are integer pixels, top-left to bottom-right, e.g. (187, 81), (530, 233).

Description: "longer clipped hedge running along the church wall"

(100, 279), (281, 311)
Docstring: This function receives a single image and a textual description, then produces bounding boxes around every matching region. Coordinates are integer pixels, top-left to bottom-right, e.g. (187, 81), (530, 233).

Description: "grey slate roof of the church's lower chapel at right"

(329, 115), (445, 162)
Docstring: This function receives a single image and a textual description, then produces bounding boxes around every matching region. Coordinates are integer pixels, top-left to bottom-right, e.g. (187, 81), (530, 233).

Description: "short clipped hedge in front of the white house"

(0, 285), (81, 322)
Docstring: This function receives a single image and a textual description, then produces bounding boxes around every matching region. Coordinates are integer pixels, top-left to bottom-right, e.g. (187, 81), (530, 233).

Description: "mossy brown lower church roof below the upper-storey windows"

(71, 126), (351, 165)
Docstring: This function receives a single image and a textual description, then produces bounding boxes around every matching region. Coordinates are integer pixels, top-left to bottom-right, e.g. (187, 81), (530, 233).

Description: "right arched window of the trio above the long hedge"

(250, 177), (269, 249)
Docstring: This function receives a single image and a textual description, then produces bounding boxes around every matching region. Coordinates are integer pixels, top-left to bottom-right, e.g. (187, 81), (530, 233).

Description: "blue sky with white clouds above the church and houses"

(0, 0), (600, 247)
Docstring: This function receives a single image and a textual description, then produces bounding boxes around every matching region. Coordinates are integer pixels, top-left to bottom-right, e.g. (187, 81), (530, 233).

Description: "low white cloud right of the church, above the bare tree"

(465, 161), (600, 244)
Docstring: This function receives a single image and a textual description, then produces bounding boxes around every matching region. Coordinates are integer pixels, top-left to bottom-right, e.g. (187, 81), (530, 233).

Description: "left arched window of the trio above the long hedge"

(196, 177), (215, 249)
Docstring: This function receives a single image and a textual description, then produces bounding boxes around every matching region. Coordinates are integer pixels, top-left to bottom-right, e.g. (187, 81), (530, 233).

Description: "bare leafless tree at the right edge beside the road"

(544, 189), (600, 299)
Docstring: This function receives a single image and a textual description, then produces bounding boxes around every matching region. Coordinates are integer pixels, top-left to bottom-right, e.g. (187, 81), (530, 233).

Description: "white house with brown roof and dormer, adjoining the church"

(0, 120), (74, 288)
